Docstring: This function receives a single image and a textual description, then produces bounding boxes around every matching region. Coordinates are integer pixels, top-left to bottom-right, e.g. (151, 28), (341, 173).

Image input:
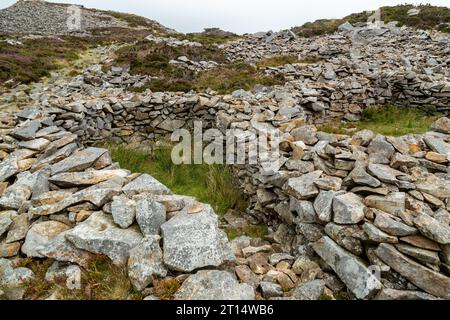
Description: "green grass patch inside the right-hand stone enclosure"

(318, 105), (437, 136)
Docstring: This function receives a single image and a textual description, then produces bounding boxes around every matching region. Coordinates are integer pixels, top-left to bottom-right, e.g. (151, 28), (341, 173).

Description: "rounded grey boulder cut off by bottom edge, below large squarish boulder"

(175, 270), (255, 300)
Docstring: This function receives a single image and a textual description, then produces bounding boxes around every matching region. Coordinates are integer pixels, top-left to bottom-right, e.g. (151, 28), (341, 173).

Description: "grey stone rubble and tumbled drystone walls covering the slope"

(0, 1), (450, 300)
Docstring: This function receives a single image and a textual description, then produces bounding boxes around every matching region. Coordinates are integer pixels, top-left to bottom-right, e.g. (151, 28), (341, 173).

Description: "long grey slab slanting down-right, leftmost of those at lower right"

(313, 237), (382, 299)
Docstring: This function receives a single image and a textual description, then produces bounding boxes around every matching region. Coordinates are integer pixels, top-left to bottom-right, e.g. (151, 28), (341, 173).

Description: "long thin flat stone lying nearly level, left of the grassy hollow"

(49, 169), (129, 188)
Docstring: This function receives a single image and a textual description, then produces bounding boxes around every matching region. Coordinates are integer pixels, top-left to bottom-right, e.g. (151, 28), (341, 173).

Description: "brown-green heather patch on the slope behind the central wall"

(114, 40), (284, 94)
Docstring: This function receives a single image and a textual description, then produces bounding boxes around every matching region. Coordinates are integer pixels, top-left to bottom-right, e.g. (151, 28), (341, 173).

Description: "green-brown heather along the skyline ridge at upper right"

(292, 4), (450, 37)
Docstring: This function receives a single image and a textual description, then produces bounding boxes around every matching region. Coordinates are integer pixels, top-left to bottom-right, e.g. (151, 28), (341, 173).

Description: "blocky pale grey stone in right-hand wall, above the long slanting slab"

(333, 193), (365, 224)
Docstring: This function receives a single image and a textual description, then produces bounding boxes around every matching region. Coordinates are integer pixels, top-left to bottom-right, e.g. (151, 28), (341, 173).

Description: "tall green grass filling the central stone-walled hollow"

(108, 145), (247, 215)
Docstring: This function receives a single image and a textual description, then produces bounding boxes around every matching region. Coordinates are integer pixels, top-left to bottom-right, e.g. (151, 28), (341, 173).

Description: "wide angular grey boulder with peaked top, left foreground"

(66, 212), (142, 265)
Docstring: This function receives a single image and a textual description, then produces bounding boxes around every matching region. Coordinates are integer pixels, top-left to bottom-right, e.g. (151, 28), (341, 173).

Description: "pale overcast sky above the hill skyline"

(0, 0), (450, 33)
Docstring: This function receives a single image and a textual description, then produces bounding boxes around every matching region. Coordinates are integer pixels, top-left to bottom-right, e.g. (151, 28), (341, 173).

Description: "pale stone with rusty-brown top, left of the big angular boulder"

(22, 221), (70, 258)
